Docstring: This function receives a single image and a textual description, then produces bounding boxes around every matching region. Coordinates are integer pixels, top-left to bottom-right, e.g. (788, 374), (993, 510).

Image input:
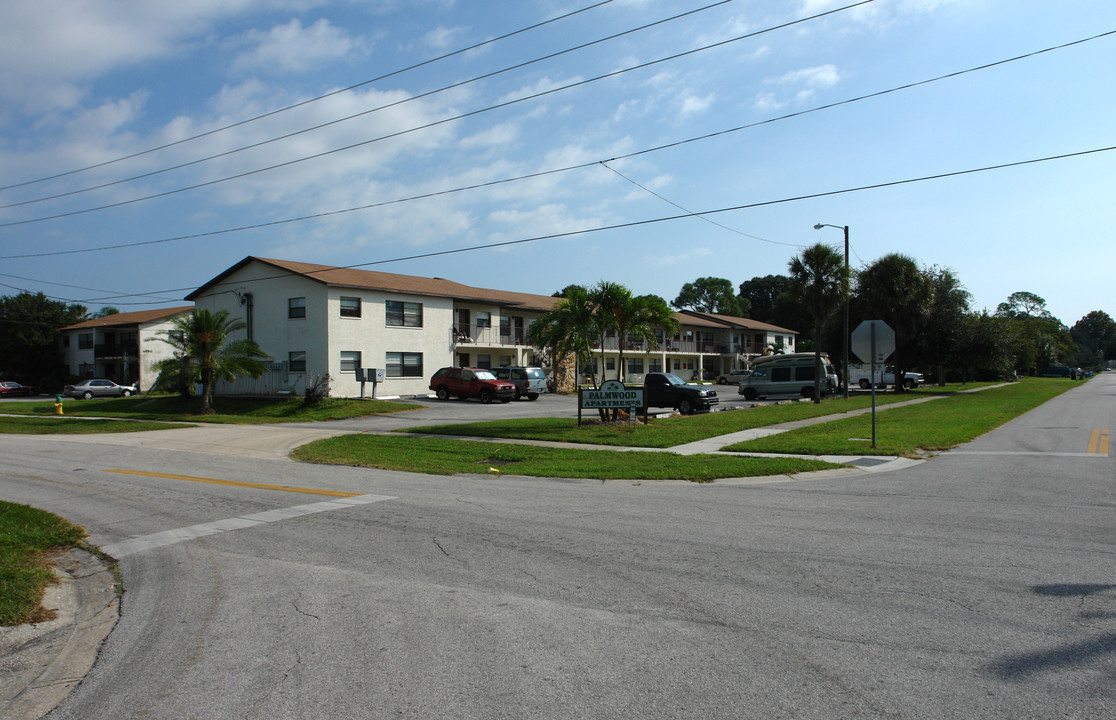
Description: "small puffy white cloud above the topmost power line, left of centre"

(232, 19), (368, 74)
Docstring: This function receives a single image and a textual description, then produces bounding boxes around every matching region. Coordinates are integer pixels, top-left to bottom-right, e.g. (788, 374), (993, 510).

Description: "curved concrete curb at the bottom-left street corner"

(0, 548), (119, 720)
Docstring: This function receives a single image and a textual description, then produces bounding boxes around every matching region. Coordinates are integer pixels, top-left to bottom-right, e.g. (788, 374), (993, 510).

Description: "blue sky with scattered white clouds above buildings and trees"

(0, 0), (1116, 329)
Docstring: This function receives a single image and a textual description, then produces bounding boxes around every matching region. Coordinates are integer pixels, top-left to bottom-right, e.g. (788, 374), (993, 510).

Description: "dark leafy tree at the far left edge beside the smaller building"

(0, 291), (88, 391)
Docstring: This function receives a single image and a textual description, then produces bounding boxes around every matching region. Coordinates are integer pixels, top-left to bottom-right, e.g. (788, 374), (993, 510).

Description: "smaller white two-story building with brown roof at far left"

(61, 307), (193, 391)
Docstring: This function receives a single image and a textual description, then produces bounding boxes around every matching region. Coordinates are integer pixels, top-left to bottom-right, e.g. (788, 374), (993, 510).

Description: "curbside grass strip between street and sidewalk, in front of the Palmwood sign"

(291, 434), (841, 482)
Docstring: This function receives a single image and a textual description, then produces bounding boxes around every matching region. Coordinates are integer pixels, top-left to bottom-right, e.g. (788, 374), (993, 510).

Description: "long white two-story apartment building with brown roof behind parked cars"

(186, 257), (795, 397)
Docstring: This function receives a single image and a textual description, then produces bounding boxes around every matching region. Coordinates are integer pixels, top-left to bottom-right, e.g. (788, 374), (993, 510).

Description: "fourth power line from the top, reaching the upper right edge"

(0, 30), (1116, 260)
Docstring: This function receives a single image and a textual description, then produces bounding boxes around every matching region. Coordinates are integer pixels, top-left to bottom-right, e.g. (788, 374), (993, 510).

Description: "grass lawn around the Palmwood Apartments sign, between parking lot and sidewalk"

(398, 384), (995, 448)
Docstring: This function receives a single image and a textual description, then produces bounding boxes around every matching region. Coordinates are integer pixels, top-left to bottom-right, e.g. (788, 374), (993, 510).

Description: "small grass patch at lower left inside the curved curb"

(0, 501), (85, 625)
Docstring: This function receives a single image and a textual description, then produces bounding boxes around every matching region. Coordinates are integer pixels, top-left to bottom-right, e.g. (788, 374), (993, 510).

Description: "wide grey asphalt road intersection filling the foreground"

(0, 374), (1116, 719)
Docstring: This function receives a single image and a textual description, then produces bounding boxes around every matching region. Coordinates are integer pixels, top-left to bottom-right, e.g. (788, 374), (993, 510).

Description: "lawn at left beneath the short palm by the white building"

(0, 395), (422, 424)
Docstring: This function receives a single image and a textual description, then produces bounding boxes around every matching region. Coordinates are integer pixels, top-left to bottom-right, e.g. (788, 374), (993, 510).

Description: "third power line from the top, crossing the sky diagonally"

(0, 0), (875, 228)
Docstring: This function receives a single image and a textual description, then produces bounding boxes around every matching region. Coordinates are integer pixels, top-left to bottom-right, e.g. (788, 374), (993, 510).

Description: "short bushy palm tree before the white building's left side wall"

(155, 308), (268, 415)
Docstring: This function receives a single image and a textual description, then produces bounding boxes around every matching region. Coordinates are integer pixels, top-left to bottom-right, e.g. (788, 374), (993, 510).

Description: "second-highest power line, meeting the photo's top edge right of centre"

(0, 0), (745, 210)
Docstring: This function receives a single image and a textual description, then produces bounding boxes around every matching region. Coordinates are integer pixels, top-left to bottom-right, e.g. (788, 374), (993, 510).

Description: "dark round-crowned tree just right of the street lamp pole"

(856, 252), (934, 392)
